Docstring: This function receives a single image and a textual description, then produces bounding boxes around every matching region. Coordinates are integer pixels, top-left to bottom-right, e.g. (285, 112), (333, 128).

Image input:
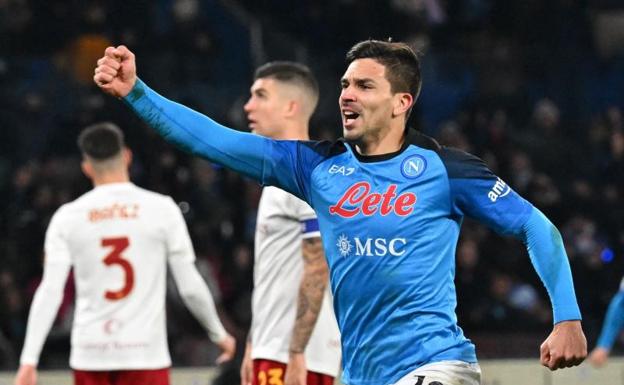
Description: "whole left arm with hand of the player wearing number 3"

(15, 211), (71, 385)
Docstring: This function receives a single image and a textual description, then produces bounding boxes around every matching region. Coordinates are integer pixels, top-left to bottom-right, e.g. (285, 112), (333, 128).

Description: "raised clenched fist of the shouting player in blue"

(93, 45), (137, 98)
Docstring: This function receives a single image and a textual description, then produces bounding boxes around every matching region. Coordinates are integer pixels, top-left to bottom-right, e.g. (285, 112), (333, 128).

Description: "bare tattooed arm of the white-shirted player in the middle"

(284, 237), (329, 385)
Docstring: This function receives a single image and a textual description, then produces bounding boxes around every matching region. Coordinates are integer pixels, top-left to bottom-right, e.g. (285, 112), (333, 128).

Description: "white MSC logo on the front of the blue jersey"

(336, 234), (407, 257)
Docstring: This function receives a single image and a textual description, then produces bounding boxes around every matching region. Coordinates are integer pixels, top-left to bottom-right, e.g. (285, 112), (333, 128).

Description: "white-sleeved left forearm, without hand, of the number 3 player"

(20, 263), (70, 366)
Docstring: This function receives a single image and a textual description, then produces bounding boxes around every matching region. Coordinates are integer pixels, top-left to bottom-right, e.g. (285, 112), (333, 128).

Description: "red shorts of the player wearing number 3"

(74, 368), (169, 385)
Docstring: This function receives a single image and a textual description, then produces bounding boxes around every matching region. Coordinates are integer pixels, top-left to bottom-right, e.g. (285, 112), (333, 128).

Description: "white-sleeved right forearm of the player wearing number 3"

(170, 261), (227, 343)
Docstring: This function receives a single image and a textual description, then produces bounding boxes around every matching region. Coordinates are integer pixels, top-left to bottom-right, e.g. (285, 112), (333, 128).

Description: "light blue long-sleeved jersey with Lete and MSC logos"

(125, 81), (580, 385)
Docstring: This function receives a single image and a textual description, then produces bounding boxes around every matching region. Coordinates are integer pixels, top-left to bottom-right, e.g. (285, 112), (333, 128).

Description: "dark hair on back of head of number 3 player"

(78, 122), (124, 161)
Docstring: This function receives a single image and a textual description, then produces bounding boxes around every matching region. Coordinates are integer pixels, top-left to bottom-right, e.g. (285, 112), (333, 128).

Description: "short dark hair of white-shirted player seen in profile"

(254, 61), (319, 99)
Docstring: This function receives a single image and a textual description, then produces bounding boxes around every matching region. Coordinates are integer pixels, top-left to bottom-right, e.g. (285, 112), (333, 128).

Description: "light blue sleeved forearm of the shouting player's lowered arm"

(523, 208), (581, 323)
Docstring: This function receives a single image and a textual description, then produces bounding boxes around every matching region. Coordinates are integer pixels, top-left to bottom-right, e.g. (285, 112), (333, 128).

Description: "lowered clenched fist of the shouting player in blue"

(540, 321), (587, 370)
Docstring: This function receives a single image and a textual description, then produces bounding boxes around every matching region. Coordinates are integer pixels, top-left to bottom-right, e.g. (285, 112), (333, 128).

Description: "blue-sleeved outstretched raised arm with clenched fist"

(94, 46), (326, 200)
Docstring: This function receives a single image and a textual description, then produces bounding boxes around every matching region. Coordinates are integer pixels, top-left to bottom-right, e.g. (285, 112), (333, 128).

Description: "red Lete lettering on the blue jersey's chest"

(329, 182), (416, 218)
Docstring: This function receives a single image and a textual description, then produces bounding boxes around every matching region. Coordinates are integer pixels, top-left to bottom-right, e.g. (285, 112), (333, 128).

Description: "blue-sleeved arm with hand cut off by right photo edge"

(589, 288), (624, 368)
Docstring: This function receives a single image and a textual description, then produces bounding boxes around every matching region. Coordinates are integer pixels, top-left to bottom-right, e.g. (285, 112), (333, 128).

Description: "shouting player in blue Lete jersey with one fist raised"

(94, 40), (587, 385)
